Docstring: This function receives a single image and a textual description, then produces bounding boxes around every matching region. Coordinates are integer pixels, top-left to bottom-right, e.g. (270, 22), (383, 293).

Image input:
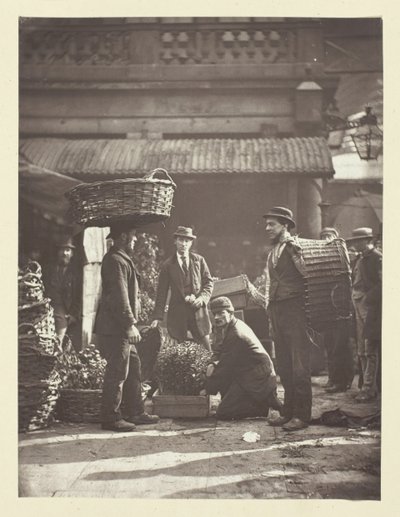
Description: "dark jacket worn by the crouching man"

(207, 317), (276, 402)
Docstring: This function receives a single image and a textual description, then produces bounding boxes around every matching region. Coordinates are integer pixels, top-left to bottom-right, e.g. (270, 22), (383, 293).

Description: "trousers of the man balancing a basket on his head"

(97, 334), (144, 423)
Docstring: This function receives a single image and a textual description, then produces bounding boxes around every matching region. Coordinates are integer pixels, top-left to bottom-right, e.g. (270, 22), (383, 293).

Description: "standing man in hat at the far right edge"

(346, 227), (382, 402)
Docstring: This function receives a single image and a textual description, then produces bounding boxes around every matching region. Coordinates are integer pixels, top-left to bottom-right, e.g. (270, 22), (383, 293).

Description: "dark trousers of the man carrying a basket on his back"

(268, 297), (312, 422)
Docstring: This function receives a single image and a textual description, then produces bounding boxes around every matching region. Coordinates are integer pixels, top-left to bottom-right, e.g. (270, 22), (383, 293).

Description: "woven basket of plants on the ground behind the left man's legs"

(56, 388), (102, 423)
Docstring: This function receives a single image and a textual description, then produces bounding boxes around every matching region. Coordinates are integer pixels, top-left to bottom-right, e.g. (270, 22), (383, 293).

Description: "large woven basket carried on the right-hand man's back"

(298, 238), (351, 331)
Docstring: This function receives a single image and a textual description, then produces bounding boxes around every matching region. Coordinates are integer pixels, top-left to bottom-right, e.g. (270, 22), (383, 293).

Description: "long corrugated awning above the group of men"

(20, 137), (334, 177)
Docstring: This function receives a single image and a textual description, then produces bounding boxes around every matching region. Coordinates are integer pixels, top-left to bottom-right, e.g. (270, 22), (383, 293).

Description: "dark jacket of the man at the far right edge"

(353, 248), (382, 339)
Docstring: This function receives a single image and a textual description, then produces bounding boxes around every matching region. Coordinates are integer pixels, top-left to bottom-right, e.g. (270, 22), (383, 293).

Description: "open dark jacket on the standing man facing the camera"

(153, 253), (214, 338)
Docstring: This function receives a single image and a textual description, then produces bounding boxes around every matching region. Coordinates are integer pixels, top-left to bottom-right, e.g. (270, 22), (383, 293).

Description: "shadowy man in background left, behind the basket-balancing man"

(44, 237), (82, 350)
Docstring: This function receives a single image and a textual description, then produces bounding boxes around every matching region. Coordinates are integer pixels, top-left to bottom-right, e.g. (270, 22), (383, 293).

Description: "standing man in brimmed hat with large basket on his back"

(264, 206), (312, 431)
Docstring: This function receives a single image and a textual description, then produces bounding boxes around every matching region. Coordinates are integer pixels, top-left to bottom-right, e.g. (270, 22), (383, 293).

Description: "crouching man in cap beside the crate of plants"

(206, 296), (281, 420)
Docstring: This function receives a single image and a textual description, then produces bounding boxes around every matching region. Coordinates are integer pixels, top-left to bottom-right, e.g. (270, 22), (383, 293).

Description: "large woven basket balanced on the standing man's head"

(65, 169), (176, 227)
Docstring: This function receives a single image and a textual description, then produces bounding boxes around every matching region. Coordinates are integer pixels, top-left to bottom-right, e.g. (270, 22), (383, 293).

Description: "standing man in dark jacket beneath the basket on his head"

(95, 223), (159, 432)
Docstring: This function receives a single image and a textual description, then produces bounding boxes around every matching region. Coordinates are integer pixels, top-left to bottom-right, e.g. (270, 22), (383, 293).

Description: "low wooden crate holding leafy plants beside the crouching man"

(152, 395), (210, 418)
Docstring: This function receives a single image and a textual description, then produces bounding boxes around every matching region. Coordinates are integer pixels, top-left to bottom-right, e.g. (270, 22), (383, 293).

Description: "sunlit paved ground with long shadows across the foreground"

(19, 377), (380, 500)
